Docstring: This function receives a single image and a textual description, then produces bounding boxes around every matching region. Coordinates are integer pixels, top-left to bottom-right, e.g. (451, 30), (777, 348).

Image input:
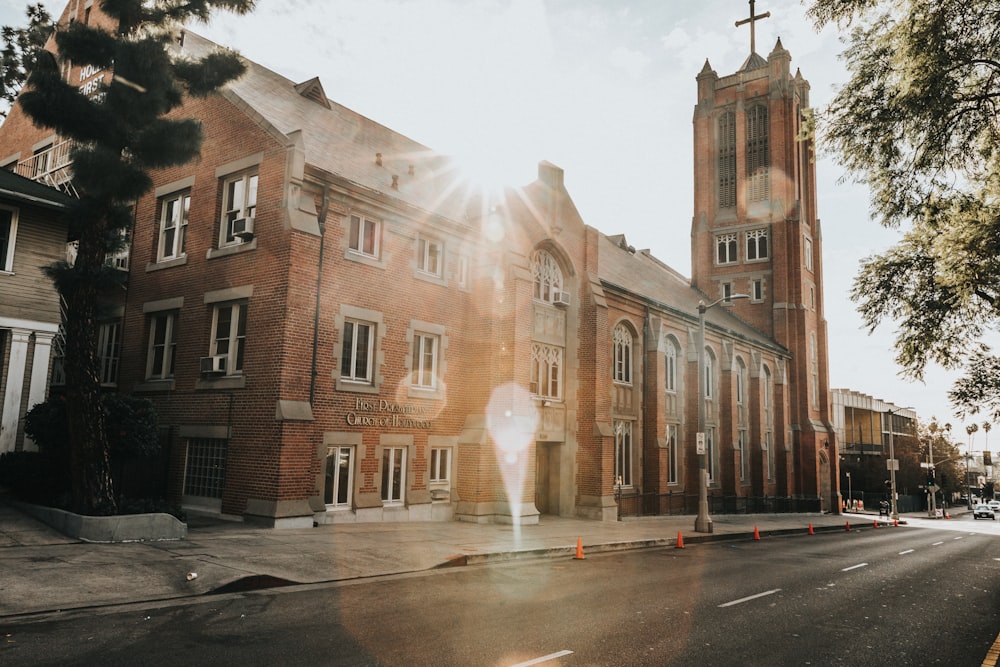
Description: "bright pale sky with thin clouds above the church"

(0, 0), (982, 442)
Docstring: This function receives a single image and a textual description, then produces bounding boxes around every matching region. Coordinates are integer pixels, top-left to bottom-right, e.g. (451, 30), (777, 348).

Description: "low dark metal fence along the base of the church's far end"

(616, 491), (820, 519)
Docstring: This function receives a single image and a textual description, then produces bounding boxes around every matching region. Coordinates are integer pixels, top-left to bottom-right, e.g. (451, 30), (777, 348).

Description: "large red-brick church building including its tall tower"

(0, 0), (839, 527)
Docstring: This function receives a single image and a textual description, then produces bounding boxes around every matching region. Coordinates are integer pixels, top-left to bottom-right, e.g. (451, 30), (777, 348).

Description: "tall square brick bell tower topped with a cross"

(691, 0), (838, 511)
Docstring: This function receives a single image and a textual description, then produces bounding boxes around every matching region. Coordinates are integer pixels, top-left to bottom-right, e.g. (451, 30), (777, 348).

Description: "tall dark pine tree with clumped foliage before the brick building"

(18, 0), (254, 515)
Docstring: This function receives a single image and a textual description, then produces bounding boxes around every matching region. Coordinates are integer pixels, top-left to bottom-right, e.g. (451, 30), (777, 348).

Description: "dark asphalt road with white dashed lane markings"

(0, 518), (1000, 667)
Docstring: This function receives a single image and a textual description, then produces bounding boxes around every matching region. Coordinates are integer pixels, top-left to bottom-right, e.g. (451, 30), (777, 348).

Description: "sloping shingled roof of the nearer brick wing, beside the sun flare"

(178, 32), (478, 221)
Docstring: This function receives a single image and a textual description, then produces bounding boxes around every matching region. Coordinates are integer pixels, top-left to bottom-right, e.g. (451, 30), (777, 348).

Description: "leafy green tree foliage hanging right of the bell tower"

(809, 0), (1000, 416)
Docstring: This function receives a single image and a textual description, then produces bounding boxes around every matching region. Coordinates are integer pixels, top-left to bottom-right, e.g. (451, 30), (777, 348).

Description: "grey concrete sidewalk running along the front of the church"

(0, 502), (900, 619)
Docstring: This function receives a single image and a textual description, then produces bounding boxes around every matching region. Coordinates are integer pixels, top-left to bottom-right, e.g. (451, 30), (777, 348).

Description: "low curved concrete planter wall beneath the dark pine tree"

(16, 503), (187, 542)
